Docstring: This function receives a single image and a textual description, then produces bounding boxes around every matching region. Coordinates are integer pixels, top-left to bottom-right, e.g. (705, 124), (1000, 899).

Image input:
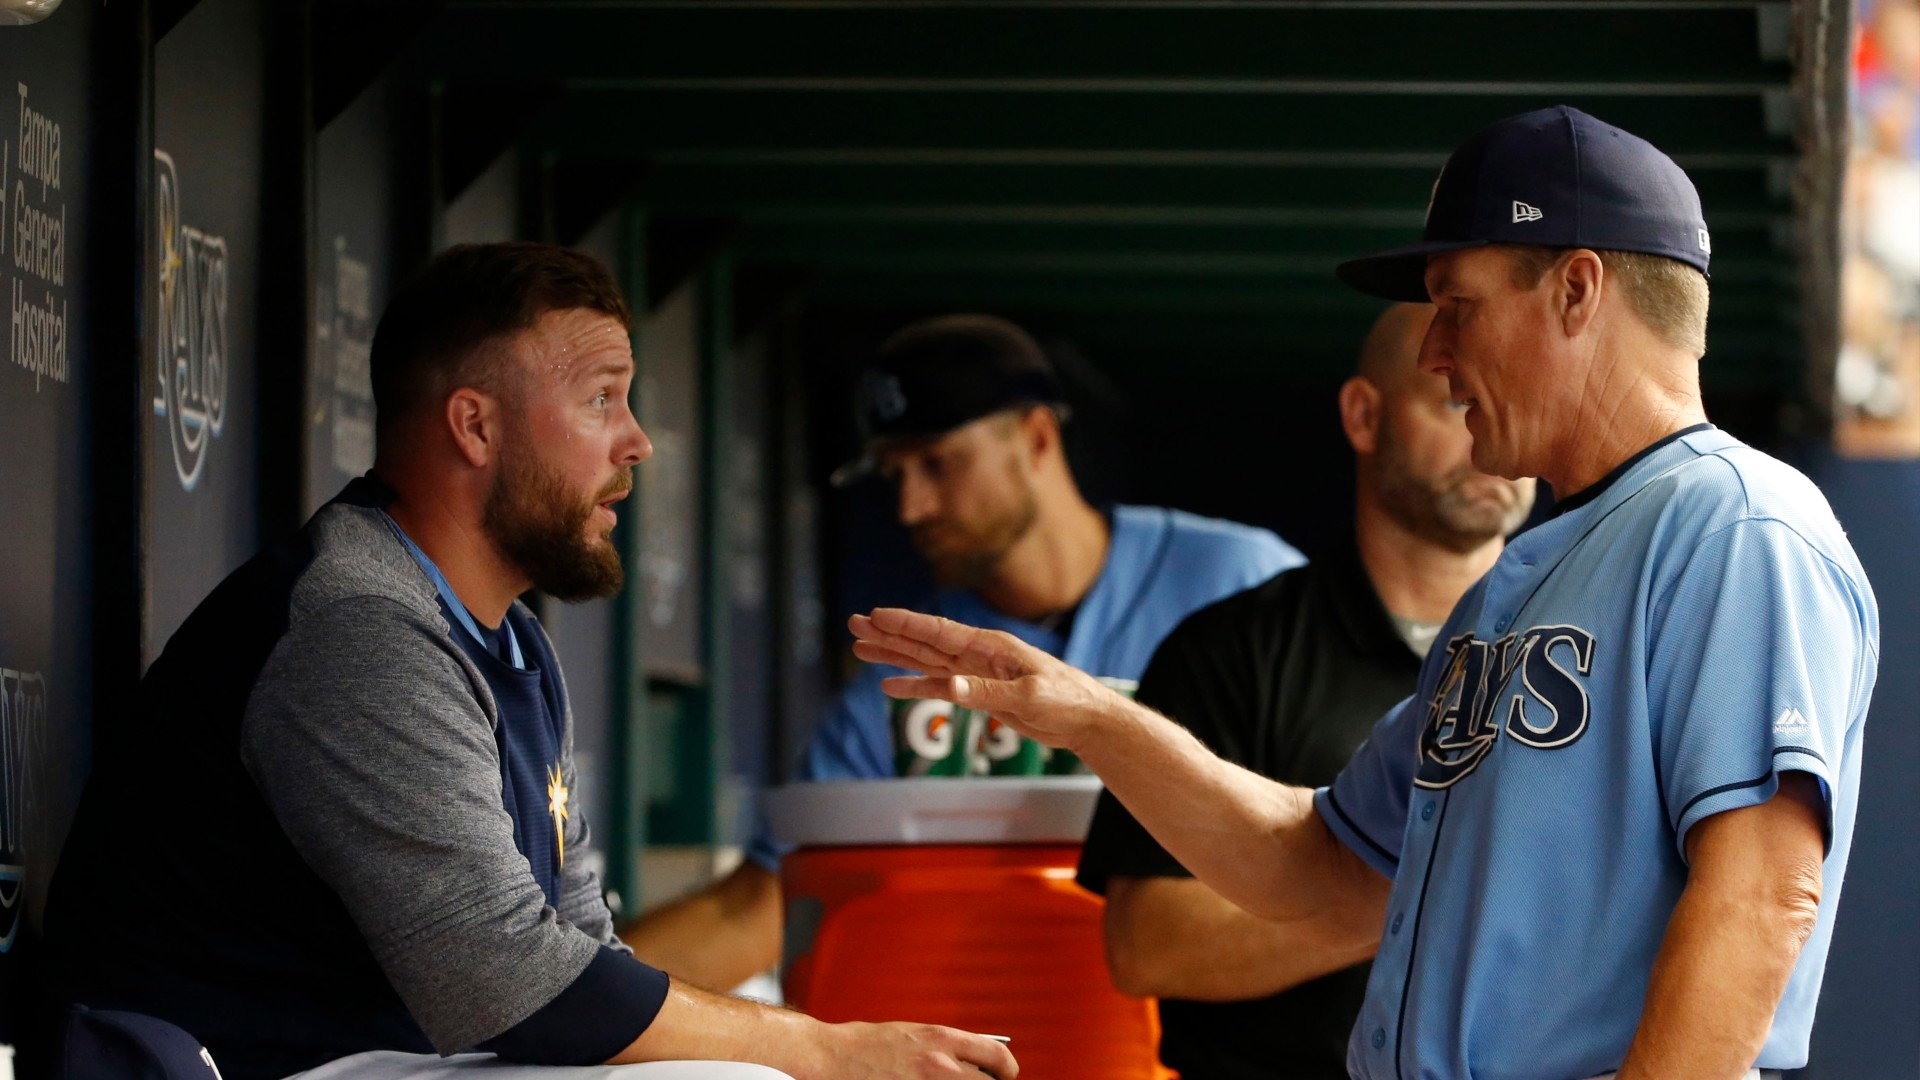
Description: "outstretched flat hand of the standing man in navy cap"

(847, 607), (1127, 751)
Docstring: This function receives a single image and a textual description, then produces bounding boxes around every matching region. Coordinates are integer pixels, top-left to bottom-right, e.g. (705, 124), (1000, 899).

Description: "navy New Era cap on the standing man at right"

(1334, 106), (1713, 304)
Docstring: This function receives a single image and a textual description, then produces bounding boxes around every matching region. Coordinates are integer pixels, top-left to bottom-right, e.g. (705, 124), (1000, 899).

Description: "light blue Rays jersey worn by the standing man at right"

(1315, 425), (1880, 1080)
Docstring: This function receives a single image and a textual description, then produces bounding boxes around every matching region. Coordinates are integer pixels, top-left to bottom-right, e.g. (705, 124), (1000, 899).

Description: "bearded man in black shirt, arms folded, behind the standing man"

(1079, 304), (1534, 1080)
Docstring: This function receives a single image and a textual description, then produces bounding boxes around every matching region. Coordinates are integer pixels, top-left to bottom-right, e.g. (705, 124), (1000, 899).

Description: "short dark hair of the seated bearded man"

(367, 242), (634, 430)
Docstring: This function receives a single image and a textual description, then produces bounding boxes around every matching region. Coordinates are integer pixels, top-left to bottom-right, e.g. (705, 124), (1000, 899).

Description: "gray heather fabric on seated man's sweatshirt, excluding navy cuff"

(240, 505), (626, 1053)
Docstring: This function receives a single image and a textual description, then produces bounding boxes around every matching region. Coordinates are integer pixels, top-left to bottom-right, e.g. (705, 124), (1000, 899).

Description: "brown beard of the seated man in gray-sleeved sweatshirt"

(480, 441), (634, 603)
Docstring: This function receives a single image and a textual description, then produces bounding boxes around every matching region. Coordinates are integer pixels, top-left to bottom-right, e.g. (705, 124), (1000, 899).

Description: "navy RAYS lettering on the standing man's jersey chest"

(1413, 626), (1594, 788)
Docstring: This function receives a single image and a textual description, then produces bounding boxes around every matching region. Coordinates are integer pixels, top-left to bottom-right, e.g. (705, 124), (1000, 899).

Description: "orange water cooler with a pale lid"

(768, 776), (1171, 1080)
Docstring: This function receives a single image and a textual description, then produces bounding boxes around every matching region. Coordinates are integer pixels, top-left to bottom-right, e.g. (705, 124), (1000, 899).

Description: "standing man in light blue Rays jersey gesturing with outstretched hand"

(854, 108), (1880, 1080)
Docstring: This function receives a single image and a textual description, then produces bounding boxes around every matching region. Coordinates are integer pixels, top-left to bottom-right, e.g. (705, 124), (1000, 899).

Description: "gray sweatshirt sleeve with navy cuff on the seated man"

(240, 598), (666, 1065)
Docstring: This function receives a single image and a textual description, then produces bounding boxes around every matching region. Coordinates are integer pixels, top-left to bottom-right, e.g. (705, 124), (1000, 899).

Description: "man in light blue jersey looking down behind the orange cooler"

(622, 315), (1306, 988)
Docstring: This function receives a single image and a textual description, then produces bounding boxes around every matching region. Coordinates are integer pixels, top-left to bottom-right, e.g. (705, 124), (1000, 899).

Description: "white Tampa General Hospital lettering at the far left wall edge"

(0, 83), (73, 392)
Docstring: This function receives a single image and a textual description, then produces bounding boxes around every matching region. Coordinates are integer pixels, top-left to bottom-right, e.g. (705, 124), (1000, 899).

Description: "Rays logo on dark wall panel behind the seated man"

(154, 148), (228, 492)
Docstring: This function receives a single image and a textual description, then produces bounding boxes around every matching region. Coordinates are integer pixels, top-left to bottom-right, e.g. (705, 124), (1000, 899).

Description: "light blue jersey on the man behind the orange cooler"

(747, 505), (1306, 869)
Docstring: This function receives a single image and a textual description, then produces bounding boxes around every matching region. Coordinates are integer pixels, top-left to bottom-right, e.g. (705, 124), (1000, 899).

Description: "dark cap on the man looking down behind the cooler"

(833, 315), (1066, 486)
